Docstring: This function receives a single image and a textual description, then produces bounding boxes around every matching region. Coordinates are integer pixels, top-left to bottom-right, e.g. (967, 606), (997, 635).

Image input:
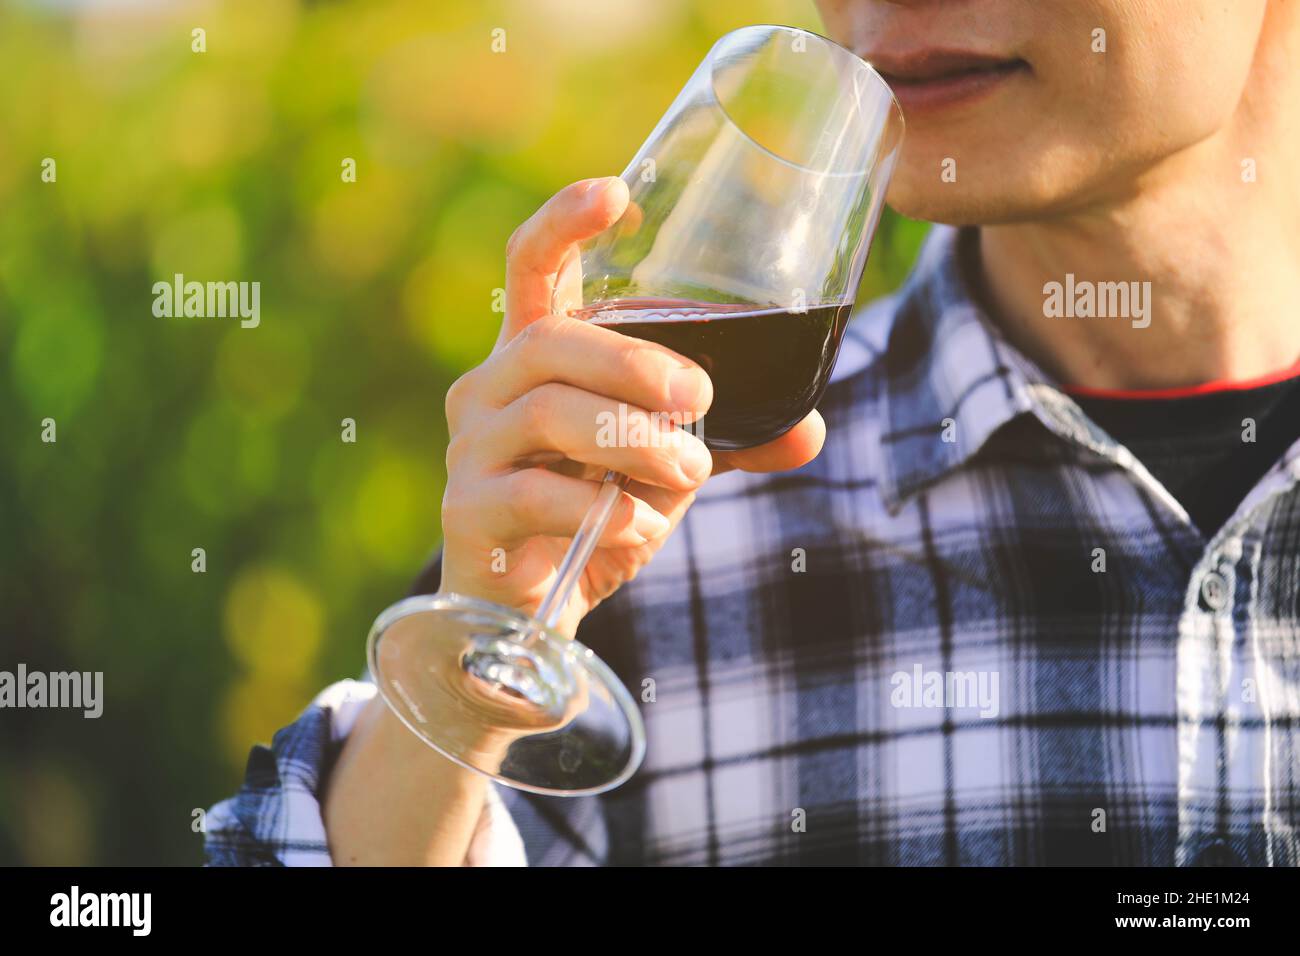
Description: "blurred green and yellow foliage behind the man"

(0, 0), (924, 864)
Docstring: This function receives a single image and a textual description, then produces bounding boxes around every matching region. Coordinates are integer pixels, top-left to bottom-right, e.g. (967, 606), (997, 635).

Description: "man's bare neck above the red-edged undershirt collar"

(980, 13), (1300, 389)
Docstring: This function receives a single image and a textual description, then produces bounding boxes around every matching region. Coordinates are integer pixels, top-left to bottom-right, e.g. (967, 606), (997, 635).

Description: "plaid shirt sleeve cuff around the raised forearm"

(204, 680), (527, 866)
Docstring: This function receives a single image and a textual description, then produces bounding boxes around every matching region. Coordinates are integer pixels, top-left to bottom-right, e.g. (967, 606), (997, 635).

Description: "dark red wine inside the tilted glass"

(573, 298), (853, 450)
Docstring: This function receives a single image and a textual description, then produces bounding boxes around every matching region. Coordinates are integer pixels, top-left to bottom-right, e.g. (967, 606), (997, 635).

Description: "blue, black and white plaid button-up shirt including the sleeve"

(208, 228), (1300, 865)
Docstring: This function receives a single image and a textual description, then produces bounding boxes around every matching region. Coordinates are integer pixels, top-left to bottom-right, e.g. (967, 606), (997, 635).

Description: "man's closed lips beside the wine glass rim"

(863, 49), (1032, 116)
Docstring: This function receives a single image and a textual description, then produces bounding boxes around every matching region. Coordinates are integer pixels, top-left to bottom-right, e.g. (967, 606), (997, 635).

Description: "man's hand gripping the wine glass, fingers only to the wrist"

(442, 178), (824, 635)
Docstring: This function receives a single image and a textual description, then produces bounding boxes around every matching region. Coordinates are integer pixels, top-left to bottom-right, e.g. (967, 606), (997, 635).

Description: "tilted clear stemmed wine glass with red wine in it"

(367, 26), (902, 795)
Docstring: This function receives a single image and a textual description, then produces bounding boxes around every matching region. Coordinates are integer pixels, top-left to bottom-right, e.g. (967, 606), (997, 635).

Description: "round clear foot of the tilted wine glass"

(367, 594), (645, 796)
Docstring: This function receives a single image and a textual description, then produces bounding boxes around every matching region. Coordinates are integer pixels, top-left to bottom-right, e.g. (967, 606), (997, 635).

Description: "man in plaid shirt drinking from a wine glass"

(208, 0), (1300, 865)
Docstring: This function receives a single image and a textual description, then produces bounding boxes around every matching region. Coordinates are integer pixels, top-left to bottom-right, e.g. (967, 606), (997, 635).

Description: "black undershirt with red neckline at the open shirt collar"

(1073, 376), (1300, 537)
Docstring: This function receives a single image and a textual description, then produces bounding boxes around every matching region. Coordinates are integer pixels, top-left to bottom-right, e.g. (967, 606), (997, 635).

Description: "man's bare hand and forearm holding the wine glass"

(324, 178), (826, 865)
